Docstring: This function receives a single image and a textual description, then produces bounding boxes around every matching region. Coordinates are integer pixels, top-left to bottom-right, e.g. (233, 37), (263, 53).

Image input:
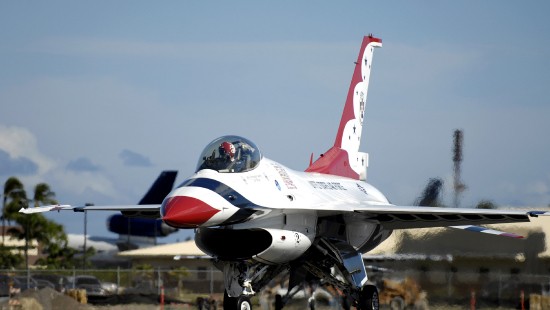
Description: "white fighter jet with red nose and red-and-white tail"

(21, 36), (548, 309)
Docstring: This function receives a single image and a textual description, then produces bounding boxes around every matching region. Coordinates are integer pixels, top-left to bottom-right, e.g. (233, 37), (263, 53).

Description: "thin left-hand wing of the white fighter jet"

(19, 204), (160, 218)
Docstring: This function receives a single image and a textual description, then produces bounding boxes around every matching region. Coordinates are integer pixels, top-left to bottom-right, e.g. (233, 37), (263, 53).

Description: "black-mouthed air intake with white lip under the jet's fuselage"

(195, 228), (314, 264)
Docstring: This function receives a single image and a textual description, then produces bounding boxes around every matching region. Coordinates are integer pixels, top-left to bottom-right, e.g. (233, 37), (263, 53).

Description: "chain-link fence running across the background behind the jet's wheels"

(0, 267), (550, 310)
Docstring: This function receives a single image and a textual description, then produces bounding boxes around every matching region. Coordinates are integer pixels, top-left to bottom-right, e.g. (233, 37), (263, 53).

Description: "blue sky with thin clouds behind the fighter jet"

(0, 1), (550, 240)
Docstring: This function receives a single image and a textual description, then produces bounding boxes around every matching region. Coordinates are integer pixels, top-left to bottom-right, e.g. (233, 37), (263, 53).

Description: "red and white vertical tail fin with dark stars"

(306, 35), (382, 179)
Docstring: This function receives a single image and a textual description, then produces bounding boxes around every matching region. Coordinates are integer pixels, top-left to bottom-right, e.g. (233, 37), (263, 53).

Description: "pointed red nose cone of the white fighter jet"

(162, 196), (220, 228)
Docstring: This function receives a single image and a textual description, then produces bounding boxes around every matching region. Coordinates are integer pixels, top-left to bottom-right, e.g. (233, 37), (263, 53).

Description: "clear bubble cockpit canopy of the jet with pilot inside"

(196, 136), (262, 173)
